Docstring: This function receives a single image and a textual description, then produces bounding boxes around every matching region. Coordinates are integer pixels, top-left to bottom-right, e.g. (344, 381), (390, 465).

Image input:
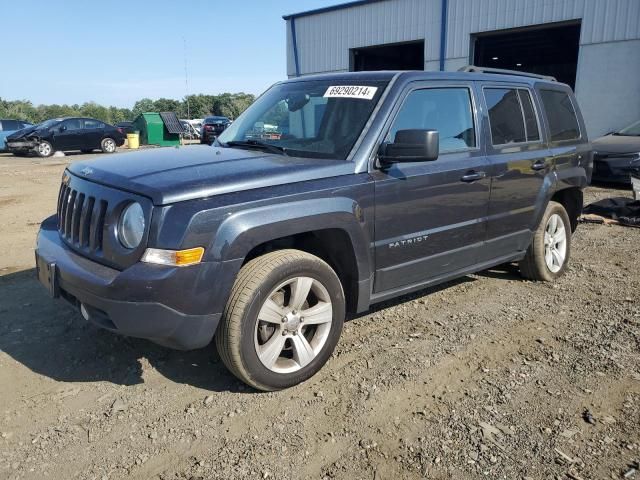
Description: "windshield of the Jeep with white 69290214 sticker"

(218, 80), (387, 160)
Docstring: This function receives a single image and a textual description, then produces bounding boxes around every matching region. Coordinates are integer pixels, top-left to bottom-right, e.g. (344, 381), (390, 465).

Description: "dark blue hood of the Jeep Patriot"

(68, 145), (354, 205)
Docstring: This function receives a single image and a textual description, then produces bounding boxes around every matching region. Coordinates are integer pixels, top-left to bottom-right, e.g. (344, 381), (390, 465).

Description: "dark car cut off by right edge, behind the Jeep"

(593, 121), (640, 185)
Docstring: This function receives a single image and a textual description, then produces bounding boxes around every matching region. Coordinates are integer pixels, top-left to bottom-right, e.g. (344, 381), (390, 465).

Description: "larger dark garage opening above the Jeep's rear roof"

(473, 22), (580, 88)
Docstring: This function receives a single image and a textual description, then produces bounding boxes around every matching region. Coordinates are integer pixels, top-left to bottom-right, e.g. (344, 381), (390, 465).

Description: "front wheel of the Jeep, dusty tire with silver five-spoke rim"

(215, 250), (345, 391)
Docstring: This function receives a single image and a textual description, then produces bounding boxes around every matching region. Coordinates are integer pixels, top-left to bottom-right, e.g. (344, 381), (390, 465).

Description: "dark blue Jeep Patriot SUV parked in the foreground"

(36, 68), (592, 390)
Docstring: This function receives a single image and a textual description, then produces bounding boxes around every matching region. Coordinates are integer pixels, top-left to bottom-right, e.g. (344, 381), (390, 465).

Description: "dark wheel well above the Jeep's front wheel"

(243, 228), (358, 313)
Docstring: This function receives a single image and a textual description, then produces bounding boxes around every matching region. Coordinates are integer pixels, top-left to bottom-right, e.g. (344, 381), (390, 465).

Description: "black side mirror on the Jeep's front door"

(379, 129), (440, 164)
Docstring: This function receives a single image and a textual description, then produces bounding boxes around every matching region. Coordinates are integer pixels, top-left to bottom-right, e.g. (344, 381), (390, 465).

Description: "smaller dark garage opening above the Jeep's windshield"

(350, 40), (424, 72)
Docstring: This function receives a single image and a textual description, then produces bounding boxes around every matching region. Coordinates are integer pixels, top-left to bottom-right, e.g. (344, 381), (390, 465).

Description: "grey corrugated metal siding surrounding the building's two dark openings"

(287, 0), (640, 76)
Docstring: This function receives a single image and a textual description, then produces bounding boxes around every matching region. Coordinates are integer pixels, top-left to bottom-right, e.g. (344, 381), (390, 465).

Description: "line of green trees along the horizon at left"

(0, 93), (255, 124)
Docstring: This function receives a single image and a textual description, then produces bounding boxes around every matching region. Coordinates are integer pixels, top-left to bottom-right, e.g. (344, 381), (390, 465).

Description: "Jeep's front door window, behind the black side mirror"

(385, 87), (476, 153)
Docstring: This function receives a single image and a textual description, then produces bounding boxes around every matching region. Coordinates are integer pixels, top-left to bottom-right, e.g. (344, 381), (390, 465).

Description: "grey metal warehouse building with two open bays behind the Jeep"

(284, 0), (640, 138)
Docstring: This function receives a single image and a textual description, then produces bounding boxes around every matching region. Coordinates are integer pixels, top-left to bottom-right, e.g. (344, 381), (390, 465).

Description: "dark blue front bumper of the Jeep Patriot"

(36, 216), (224, 350)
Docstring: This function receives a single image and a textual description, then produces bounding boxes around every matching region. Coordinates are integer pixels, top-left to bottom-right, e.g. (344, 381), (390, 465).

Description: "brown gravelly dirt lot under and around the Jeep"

(0, 151), (640, 480)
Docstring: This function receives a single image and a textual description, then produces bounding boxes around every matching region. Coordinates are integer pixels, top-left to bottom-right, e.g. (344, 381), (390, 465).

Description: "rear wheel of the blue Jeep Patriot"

(520, 202), (571, 282)
